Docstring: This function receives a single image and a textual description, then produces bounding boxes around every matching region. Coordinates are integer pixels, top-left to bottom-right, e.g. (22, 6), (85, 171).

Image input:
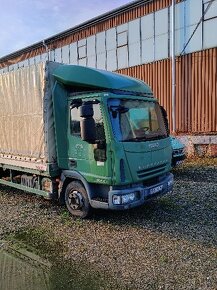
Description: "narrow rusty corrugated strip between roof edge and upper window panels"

(0, 0), (171, 68)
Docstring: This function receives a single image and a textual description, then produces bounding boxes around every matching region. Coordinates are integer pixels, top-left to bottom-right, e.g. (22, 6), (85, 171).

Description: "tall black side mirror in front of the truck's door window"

(80, 103), (96, 144)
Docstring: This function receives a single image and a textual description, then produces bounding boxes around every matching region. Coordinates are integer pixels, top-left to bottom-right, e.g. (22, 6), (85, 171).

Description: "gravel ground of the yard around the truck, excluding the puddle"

(0, 159), (217, 290)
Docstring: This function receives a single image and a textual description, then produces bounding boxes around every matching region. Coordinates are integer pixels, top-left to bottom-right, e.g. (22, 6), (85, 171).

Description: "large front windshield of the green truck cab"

(108, 99), (167, 142)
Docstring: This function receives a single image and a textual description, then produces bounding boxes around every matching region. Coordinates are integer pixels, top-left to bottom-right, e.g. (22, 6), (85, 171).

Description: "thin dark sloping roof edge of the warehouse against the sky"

(0, 0), (152, 63)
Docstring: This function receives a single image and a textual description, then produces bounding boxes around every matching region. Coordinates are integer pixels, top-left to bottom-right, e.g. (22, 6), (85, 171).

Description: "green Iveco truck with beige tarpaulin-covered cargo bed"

(0, 62), (173, 218)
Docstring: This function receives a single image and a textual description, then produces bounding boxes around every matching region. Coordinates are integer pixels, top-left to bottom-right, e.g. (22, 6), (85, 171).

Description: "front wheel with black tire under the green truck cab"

(65, 181), (91, 218)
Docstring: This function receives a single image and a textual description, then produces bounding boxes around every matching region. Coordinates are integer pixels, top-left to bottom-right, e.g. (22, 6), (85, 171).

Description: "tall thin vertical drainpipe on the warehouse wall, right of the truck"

(171, 0), (176, 133)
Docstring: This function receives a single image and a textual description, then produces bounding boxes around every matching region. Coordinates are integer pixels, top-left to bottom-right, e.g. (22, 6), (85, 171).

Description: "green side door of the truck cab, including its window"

(68, 103), (111, 184)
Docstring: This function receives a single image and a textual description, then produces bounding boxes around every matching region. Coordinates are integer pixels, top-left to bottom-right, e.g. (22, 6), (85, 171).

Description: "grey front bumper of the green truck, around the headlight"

(108, 173), (174, 210)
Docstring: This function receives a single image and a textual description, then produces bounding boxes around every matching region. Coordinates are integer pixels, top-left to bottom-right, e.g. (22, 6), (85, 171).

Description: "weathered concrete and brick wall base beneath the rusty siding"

(176, 135), (217, 157)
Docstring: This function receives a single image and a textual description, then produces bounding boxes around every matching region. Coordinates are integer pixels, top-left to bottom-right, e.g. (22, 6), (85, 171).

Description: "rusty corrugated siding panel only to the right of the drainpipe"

(176, 48), (217, 133)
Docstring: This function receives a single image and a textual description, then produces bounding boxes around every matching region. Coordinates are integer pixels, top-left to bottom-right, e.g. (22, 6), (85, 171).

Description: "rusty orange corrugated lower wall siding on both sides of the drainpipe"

(118, 48), (217, 134)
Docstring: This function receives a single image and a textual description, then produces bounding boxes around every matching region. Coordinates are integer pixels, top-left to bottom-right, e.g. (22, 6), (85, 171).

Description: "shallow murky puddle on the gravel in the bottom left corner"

(0, 241), (113, 290)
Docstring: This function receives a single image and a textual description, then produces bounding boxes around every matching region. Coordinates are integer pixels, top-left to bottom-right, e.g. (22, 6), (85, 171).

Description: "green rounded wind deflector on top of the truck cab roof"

(53, 65), (153, 95)
